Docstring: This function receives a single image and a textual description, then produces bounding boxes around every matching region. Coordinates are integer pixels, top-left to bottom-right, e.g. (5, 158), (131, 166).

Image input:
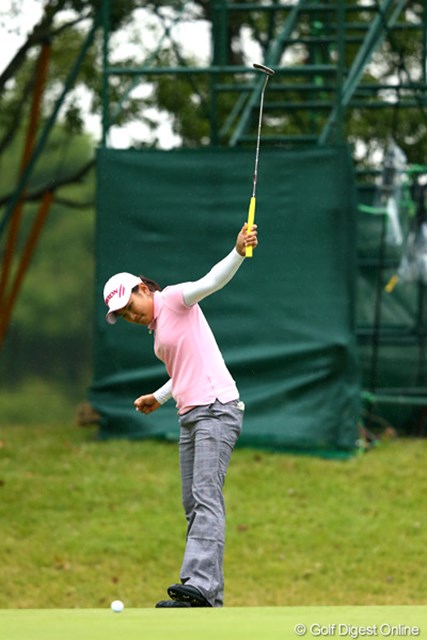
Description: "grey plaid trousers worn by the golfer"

(179, 400), (244, 607)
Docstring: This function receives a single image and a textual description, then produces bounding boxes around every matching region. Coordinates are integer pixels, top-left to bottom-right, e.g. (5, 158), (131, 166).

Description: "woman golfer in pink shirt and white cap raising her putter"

(104, 224), (258, 607)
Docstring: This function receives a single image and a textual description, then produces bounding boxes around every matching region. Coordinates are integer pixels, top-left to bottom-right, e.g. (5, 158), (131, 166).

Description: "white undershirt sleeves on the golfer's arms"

(153, 247), (245, 404)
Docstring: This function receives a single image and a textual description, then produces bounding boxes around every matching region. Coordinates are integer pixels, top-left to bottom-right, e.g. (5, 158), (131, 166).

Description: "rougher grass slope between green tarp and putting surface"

(0, 424), (427, 609)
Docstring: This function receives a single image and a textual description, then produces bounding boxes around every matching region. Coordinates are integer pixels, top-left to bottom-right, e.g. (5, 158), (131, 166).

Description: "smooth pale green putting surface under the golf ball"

(0, 606), (427, 640)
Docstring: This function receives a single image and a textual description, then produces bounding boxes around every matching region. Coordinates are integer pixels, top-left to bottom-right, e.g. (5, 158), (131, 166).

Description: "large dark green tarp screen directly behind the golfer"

(90, 146), (360, 455)
